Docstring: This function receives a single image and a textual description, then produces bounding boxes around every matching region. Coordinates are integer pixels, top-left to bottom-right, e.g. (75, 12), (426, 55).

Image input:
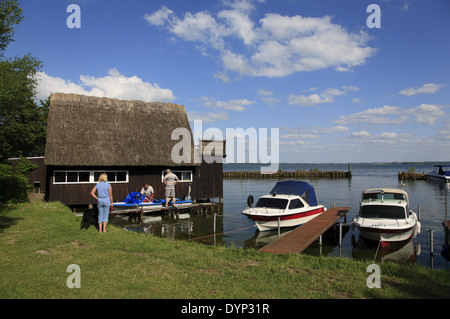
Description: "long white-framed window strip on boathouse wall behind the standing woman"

(53, 171), (128, 184)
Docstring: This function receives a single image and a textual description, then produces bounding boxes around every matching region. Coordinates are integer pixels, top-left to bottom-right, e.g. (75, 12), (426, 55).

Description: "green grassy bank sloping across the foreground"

(0, 202), (450, 299)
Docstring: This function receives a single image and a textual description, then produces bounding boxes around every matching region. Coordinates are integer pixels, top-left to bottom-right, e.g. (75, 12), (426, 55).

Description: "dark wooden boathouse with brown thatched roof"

(45, 93), (223, 205)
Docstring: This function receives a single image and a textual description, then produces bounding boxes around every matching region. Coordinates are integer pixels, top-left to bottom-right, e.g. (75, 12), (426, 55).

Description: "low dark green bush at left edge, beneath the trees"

(0, 176), (28, 203)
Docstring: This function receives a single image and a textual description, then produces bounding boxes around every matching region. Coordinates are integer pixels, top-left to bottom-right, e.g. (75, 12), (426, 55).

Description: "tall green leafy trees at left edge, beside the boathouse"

(0, 0), (50, 165)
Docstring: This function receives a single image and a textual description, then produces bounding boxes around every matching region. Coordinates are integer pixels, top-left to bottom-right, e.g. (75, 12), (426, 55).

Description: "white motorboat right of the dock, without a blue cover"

(353, 188), (420, 245)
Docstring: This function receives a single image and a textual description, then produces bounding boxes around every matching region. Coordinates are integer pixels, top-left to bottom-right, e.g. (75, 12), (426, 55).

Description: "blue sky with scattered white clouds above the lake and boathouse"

(6, 0), (450, 163)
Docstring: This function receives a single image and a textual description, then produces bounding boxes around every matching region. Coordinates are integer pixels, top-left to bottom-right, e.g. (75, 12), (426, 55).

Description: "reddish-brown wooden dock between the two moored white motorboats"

(260, 207), (350, 254)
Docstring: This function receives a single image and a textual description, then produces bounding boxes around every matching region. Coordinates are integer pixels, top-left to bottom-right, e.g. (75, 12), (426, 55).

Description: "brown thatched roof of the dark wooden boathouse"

(45, 93), (199, 167)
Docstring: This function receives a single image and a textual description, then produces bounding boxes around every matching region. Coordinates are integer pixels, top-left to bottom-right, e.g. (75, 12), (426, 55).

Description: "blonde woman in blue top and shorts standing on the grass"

(91, 173), (113, 233)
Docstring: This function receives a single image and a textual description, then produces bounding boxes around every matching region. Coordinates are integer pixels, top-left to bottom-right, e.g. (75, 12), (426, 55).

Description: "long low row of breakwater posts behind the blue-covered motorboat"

(223, 171), (352, 179)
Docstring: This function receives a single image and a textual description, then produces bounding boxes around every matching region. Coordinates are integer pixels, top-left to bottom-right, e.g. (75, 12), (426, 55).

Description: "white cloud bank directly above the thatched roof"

(37, 68), (175, 102)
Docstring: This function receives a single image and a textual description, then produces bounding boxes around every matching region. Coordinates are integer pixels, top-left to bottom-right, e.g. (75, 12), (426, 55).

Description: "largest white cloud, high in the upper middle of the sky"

(144, 0), (376, 80)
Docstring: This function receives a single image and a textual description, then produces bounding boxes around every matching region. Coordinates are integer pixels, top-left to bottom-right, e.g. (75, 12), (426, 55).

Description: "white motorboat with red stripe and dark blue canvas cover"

(242, 181), (326, 231)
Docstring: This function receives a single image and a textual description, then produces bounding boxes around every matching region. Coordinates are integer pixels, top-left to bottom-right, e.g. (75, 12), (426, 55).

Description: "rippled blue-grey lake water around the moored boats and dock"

(111, 163), (449, 269)
